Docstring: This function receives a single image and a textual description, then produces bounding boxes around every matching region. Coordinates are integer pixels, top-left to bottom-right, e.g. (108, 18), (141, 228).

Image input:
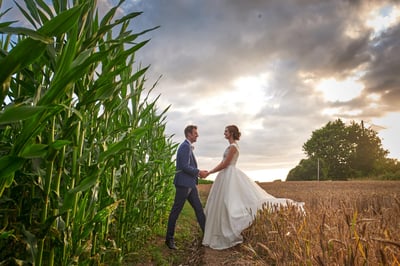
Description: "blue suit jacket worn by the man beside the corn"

(174, 140), (200, 188)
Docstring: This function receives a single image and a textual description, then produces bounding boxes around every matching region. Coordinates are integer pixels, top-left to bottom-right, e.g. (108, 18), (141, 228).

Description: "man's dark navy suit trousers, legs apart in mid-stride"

(166, 186), (206, 240)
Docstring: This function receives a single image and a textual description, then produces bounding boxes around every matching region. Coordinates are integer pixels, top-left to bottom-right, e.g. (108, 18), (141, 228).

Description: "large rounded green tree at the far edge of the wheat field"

(296, 119), (388, 180)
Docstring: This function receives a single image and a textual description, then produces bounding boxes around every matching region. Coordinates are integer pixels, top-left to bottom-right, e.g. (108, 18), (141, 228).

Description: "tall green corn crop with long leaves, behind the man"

(0, 0), (176, 265)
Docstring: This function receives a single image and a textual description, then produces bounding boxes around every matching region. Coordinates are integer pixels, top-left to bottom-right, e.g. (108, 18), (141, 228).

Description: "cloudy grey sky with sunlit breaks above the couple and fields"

(3, 0), (400, 181)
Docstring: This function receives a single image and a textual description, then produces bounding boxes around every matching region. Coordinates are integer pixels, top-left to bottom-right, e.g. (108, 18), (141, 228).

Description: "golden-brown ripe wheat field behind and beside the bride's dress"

(199, 181), (400, 265)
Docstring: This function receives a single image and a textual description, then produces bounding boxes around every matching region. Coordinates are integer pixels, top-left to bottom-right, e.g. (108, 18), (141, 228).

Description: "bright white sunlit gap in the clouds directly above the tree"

(316, 78), (364, 102)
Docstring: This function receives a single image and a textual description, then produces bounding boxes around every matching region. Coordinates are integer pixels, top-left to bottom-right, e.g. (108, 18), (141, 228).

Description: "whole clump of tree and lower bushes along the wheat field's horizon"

(286, 119), (400, 181)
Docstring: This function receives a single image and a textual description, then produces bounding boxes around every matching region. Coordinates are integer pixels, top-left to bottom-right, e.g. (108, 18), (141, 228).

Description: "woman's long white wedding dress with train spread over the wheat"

(203, 143), (304, 249)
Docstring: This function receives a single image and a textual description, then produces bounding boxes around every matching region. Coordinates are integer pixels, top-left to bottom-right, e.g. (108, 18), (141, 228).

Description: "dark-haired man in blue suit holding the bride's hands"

(165, 125), (208, 249)
